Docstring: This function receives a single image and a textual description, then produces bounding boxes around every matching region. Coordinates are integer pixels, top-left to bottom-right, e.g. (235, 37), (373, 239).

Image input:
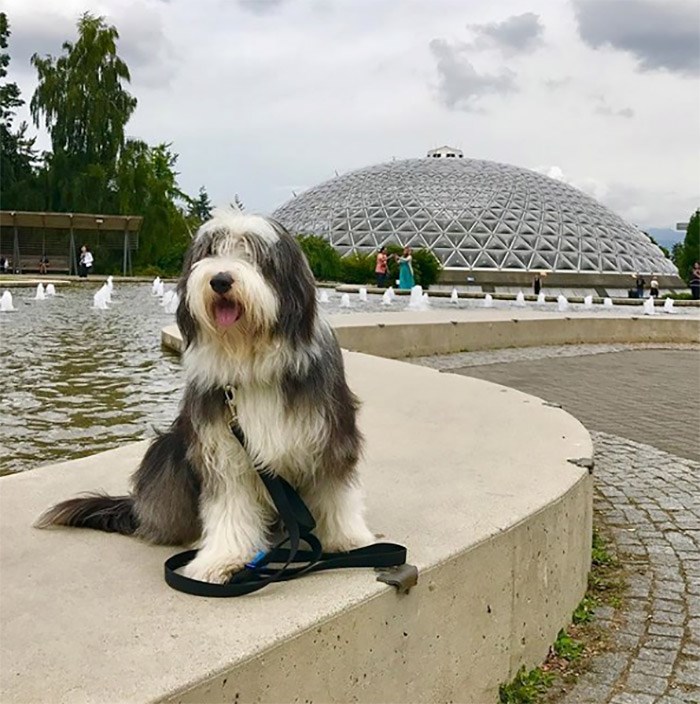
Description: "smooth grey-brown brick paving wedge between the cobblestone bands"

(446, 349), (700, 461)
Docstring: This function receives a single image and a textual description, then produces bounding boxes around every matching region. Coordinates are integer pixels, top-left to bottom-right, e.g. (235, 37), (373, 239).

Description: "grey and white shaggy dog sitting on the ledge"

(38, 211), (374, 583)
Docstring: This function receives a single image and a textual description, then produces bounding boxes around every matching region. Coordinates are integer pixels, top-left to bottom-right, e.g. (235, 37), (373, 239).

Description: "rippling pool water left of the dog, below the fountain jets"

(0, 284), (183, 473)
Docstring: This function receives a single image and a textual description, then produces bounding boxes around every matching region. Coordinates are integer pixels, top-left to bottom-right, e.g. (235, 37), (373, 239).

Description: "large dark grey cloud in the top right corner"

(573, 0), (700, 76)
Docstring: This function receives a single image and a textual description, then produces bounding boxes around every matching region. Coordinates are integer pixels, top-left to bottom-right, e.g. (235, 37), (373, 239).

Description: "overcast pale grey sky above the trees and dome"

(3, 0), (700, 227)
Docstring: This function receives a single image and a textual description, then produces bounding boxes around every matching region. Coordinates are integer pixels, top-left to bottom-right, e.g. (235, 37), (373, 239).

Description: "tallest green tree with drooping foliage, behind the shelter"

(30, 12), (136, 211)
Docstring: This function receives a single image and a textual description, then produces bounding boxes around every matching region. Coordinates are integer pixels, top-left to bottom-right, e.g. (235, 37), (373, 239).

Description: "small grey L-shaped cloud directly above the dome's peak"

(430, 39), (517, 111)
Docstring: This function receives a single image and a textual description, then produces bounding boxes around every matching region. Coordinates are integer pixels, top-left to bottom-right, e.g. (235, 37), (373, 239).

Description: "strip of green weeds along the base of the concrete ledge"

(499, 529), (624, 704)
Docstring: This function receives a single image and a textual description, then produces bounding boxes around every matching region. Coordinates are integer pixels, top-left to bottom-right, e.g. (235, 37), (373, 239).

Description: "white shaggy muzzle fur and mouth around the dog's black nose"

(186, 256), (278, 341)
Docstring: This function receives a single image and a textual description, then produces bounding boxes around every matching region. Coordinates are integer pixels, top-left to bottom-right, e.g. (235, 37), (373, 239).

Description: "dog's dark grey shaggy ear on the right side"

(262, 221), (316, 347)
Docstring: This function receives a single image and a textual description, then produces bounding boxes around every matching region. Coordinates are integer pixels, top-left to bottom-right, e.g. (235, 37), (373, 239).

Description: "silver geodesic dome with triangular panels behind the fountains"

(273, 158), (677, 275)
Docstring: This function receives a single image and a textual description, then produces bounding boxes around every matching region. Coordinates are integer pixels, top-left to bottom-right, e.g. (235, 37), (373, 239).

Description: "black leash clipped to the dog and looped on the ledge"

(165, 387), (418, 597)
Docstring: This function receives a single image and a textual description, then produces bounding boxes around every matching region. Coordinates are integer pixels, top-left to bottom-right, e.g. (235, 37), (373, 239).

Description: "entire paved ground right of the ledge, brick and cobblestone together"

(416, 345), (700, 704)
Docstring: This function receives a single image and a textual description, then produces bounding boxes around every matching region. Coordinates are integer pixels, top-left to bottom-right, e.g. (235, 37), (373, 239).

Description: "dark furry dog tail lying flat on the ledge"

(35, 494), (138, 535)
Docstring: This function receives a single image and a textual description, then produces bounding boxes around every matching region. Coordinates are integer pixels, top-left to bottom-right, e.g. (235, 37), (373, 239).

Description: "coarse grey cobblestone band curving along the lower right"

(561, 433), (700, 704)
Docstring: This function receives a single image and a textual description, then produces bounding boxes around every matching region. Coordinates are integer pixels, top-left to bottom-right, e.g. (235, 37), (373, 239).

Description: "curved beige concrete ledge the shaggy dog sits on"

(0, 353), (592, 704)
